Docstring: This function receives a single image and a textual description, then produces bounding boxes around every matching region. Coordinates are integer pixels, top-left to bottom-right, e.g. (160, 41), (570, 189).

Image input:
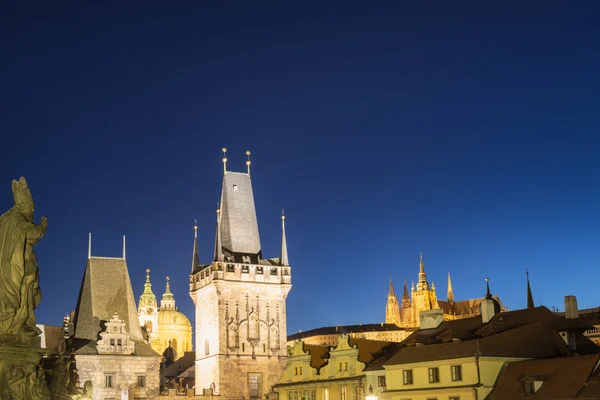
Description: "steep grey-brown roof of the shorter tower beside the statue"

(74, 257), (143, 341)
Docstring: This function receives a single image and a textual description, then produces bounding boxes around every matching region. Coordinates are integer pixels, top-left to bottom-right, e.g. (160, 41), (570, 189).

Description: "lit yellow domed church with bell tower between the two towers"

(138, 269), (192, 359)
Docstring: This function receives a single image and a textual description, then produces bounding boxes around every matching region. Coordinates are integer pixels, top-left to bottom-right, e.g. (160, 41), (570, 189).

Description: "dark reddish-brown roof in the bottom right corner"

(486, 354), (600, 400)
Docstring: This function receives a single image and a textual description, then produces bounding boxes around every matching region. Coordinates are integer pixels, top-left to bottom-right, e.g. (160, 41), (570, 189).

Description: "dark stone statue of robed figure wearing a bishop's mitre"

(0, 177), (48, 337)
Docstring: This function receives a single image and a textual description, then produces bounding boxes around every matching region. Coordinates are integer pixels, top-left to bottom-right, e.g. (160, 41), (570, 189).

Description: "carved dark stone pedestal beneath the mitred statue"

(0, 335), (50, 400)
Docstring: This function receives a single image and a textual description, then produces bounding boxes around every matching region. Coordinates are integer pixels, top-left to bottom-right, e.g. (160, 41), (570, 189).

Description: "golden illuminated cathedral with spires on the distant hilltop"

(385, 253), (507, 328)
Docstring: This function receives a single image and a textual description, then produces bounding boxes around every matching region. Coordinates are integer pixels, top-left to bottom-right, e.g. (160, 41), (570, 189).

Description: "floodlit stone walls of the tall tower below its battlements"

(191, 280), (290, 400)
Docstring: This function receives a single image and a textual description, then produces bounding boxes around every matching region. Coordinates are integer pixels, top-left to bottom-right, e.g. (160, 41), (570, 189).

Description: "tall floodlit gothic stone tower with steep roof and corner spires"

(190, 149), (292, 400)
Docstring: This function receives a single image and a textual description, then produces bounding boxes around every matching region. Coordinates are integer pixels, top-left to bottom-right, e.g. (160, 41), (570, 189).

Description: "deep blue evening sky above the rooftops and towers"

(0, 1), (600, 333)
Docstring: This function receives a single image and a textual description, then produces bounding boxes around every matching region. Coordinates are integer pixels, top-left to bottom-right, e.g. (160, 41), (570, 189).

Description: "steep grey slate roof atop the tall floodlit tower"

(221, 171), (261, 261)
